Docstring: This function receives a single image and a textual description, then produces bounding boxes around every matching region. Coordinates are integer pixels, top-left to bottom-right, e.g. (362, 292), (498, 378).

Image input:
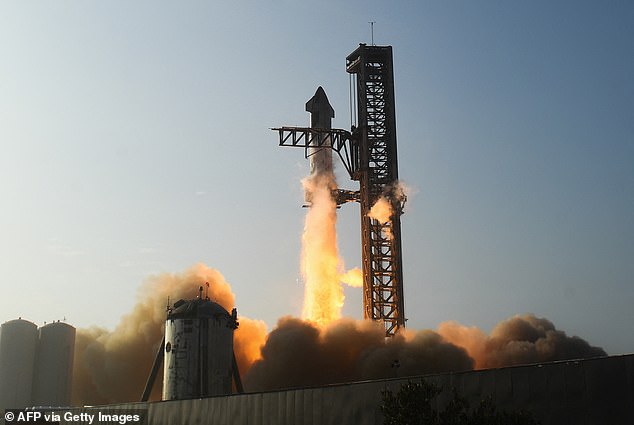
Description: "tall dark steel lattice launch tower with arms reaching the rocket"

(273, 44), (405, 336)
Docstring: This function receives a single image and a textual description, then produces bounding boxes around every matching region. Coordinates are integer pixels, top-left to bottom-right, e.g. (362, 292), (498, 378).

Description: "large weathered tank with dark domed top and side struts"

(163, 297), (238, 400)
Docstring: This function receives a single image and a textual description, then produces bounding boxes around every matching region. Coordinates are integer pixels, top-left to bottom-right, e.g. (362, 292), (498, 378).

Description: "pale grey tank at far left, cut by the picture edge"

(0, 319), (37, 410)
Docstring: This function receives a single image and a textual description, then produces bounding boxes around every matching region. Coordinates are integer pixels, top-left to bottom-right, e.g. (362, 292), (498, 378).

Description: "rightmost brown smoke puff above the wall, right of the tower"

(438, 314), (606, 369)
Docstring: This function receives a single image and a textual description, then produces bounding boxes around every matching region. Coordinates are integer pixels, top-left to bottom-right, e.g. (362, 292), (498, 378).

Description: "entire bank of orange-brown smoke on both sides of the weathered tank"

(73, 264), (605, 405)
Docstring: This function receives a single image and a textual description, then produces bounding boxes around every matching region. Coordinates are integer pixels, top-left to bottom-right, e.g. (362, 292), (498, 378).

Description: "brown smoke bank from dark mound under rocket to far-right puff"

(245, 315), (606, 391)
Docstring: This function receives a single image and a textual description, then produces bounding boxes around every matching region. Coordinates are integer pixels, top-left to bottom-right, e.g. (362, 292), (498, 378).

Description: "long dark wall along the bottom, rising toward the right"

(75, 354), (634, 425)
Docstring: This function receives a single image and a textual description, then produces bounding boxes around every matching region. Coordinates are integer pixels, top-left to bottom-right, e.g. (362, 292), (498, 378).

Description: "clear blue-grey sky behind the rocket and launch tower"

(0, 0), (634, 354)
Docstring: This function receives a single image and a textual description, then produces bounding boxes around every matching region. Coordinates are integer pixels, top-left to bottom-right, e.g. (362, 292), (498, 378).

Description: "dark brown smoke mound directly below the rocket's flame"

(245, 317), (473, 391)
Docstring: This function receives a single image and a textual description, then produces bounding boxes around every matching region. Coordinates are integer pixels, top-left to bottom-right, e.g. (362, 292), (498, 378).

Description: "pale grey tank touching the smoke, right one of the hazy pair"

(33, 321), (75, 406)
